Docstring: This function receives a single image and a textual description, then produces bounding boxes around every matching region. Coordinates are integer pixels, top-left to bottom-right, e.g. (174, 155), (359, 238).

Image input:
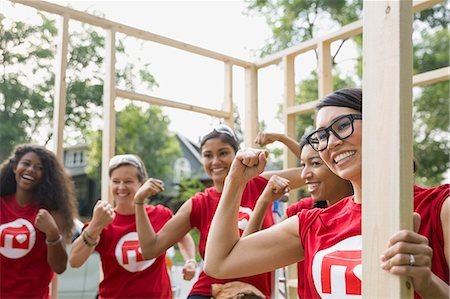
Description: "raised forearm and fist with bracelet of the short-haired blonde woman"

(69, 200), (115, 268)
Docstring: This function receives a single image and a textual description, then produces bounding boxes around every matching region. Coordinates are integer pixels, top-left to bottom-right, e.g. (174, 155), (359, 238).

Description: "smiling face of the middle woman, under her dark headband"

(202, 138), (235, 192)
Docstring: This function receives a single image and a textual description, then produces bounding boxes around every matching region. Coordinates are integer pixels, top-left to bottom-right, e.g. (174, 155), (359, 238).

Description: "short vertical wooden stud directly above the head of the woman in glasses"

(317, 40), (333, 99)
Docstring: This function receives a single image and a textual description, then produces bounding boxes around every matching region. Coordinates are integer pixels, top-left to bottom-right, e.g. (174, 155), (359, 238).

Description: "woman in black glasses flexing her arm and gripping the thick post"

(205, 89), (450, 298)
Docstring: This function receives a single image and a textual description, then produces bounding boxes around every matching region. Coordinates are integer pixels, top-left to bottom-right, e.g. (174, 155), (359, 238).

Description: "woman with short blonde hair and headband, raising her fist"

(69, 154), (195, 299)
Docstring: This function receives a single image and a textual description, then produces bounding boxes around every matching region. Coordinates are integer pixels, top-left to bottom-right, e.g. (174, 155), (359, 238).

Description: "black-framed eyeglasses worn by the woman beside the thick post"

(306, 114), (362, 152)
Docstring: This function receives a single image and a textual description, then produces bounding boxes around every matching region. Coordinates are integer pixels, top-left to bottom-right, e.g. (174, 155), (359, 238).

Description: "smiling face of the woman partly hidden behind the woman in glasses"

(300, 144), (351, 204)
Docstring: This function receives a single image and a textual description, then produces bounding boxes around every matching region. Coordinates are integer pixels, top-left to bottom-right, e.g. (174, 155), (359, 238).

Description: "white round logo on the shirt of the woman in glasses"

(312, 236), (362, 299)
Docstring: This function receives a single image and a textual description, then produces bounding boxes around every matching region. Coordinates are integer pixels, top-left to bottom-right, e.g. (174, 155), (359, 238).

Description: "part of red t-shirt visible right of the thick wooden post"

(414, 184), (450, 298)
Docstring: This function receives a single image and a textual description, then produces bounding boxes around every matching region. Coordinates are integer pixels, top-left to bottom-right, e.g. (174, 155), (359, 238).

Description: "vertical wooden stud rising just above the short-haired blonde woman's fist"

(101, 28), (116, 203)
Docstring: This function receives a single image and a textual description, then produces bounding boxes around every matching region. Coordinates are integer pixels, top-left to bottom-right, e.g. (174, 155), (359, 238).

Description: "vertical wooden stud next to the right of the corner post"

(281, 56), (299, 298)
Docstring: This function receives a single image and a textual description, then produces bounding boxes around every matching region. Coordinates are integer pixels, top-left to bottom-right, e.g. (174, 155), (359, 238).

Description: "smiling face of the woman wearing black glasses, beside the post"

(316, 106), (362, 185)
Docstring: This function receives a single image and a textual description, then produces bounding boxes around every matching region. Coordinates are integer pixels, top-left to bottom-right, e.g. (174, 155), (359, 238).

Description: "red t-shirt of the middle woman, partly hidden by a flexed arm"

(190, 177), (274, 298)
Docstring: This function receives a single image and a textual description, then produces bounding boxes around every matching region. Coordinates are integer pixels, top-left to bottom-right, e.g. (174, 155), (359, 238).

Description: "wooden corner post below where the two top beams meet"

(244, 66), (259, 147)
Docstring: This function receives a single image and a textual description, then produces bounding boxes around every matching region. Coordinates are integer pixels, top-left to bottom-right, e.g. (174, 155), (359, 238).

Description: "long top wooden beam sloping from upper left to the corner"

(10, 0), (253, 68)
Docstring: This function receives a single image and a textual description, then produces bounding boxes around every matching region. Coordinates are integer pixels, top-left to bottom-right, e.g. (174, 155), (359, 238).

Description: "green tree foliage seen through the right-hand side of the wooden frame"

(246, 0), (450, 186)
